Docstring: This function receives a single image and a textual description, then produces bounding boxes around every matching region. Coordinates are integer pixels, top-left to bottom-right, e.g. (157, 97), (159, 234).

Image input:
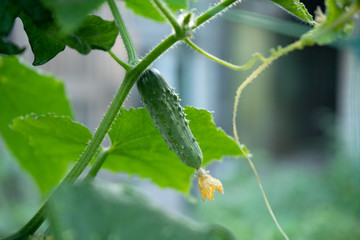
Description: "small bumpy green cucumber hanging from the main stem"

(137, 68), (203, 169)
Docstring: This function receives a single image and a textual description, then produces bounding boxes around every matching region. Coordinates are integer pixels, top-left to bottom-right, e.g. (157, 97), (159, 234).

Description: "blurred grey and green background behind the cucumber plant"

(0, 0), (360, 239)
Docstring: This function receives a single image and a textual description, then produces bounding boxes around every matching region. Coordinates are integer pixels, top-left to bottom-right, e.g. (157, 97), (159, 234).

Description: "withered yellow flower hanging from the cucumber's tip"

(196, 168), (224, 201)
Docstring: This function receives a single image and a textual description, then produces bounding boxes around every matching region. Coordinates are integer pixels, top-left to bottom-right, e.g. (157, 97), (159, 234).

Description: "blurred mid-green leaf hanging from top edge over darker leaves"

(41, 0), (105, 34)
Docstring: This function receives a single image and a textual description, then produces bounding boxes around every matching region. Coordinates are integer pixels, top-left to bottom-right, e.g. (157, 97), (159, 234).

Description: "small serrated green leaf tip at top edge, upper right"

(270, 0), (314, 25)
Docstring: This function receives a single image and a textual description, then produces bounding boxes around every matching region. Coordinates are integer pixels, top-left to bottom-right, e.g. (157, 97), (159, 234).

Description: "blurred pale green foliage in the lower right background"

(192, 150), (360, 240)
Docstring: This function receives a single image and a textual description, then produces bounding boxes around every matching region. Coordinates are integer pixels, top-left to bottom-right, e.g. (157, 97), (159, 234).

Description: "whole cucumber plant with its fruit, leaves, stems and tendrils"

(0, 0), (360, 240)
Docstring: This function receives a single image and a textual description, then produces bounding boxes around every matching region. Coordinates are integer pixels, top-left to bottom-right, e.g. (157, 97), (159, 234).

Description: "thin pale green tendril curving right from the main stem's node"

(184, 39), (266, 70)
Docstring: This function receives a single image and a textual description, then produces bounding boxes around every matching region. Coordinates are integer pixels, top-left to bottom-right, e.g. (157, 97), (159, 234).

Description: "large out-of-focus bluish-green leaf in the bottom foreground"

(48, 184), (234, 240)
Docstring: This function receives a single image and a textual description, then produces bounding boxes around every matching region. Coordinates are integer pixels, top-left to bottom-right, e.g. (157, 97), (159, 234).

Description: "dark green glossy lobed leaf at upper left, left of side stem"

(21, 14), (118, 66)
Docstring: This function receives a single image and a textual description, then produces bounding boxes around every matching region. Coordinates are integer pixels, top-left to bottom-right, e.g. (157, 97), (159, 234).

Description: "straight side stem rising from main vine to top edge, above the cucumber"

(107, 0), (139, 65)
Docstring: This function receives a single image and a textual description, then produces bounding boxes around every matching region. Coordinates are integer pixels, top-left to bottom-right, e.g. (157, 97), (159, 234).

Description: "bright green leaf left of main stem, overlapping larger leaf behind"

(11, 114), (92, 191)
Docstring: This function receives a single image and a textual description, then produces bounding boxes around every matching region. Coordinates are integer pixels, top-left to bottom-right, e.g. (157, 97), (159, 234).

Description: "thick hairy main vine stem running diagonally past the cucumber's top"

(2, 0), (237, 240)
